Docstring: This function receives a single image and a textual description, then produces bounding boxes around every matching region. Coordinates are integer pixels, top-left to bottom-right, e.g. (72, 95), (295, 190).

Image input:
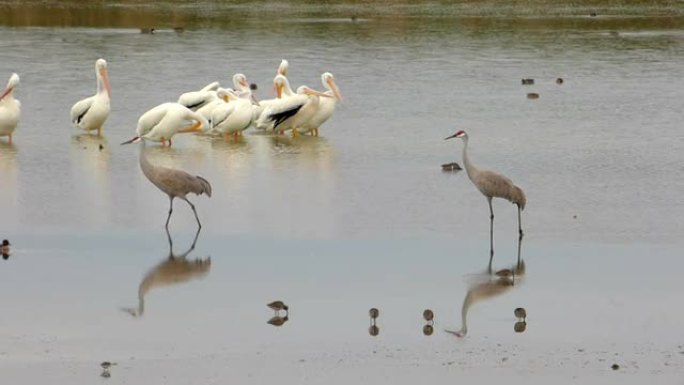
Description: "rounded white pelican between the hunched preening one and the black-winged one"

(211, 90), (252, 139)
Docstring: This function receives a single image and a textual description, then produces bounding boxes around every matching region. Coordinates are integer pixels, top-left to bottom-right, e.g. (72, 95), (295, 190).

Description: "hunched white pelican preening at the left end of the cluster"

(126, 103), (209, 146)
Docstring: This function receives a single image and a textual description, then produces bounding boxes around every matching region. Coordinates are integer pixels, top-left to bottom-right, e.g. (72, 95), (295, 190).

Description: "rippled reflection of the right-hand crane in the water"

(444, 240), (525, 337)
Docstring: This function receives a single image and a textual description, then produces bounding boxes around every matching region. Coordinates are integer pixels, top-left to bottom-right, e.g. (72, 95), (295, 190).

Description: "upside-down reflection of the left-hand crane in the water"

(121, 229), (211, 317)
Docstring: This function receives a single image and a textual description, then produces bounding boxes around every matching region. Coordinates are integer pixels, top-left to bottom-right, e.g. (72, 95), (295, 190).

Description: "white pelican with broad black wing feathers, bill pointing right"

(256, 77), (331, 137)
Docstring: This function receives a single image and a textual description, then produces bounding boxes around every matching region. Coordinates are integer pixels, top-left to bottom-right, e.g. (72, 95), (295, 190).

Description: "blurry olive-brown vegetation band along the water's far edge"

(0, 0), (684, 30)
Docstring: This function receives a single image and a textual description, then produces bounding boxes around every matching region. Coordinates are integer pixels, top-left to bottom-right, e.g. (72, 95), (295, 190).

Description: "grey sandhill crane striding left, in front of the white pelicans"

(121, 137), (211, 229)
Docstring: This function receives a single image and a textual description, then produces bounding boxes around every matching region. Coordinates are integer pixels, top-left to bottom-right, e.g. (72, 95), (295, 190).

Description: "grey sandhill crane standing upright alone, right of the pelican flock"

(444, 130), (527, 265)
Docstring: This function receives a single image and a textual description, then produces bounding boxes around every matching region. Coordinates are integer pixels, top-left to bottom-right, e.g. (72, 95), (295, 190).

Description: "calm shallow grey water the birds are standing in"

(0, 2), (684, 383)
